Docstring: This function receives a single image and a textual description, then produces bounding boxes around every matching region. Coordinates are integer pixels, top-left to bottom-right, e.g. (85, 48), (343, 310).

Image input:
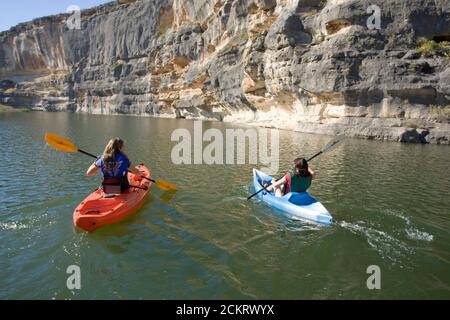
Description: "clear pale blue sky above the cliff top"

(0, 0), (111, 31)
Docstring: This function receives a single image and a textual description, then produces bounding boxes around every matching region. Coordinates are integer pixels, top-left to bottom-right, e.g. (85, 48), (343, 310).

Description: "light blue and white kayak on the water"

(253, 169), (333, 224)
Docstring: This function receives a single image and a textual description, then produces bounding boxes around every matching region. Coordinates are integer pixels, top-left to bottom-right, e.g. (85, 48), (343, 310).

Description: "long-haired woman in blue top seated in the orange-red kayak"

(86, 138), (141, 193)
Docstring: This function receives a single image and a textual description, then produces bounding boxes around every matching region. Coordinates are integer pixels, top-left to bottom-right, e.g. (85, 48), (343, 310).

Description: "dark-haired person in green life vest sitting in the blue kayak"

(263, 158), (316, 197)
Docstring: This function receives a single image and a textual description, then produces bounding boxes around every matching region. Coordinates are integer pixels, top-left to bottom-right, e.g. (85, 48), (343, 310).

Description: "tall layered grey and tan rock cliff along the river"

(0, 0), (450, 144)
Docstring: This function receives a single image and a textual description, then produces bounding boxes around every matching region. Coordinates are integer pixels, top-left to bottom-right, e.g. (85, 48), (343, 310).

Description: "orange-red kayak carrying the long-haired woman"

(73, 164), (152, 232)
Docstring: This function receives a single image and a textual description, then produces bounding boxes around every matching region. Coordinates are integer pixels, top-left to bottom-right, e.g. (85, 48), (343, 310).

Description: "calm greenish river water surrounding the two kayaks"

(0, 113), (450, 299)
